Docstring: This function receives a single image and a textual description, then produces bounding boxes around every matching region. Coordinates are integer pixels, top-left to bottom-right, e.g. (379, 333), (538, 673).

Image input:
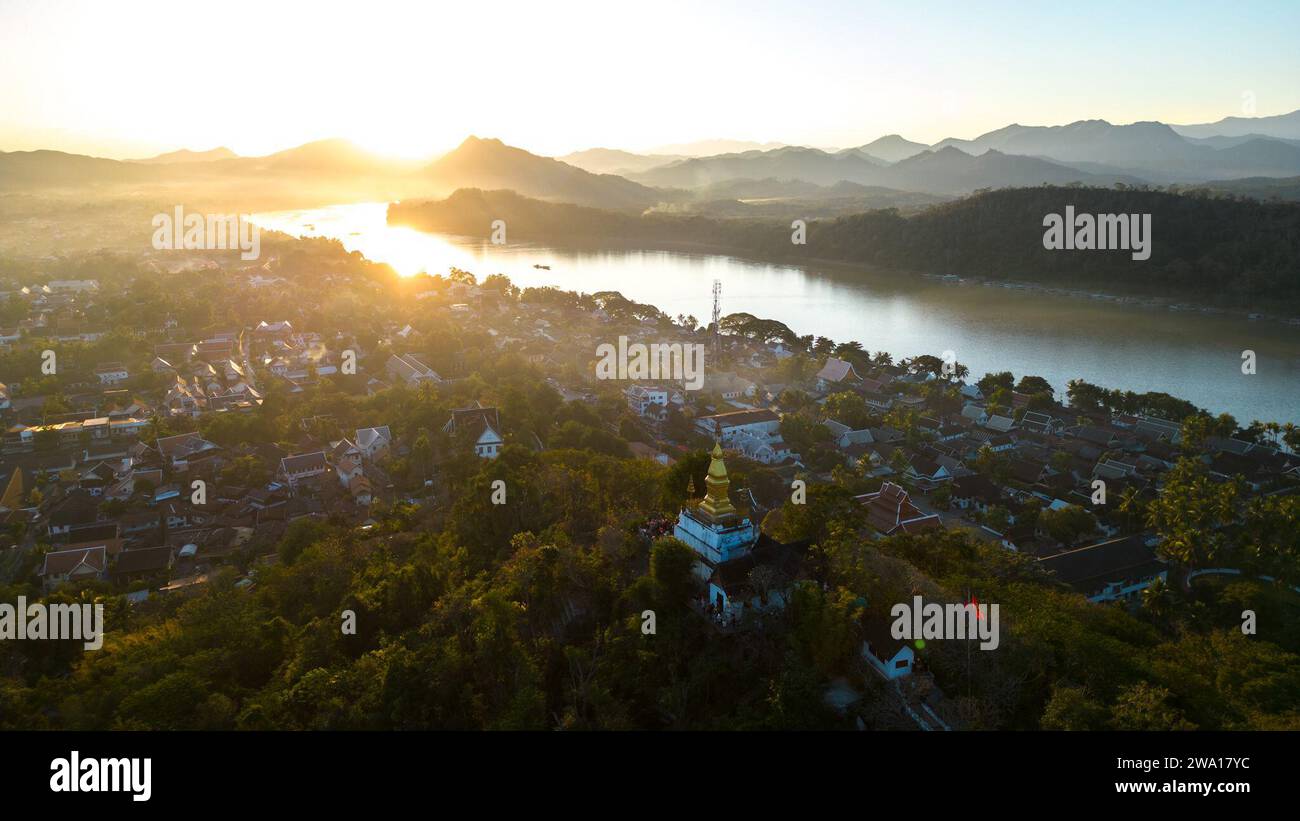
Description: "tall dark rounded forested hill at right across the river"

(794, 187), (1300, 305)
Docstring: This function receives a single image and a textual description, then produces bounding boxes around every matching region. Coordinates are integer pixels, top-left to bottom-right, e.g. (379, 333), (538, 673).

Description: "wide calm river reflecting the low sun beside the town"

(252, 203), (1300, 425)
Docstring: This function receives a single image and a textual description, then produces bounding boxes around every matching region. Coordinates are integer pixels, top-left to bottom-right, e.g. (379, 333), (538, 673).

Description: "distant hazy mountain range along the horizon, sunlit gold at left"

(0, 112), (1300, 210)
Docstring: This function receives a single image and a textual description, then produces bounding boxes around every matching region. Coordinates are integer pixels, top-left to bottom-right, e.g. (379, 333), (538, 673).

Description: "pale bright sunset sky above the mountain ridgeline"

(0, 0), (1300, 157)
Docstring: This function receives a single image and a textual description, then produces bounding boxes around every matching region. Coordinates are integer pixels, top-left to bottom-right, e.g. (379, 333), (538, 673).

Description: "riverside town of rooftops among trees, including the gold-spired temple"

(0, 229), (1300, 730)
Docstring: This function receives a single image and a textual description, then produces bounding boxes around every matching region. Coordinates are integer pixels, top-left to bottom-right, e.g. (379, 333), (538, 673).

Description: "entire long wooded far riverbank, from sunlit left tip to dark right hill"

(389, 186), (1300, 309)
